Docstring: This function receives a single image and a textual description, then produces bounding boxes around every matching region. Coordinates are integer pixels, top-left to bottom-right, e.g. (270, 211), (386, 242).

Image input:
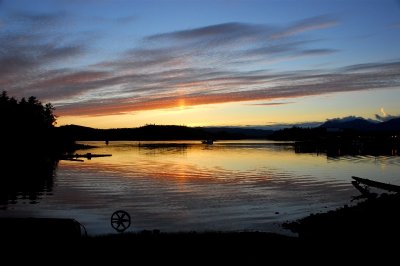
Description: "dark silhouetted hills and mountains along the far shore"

(57, 117), (400, 140)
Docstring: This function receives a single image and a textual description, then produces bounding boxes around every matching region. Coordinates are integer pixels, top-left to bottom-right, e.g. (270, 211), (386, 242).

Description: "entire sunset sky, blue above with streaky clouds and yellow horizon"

(0, 0), (400, 128)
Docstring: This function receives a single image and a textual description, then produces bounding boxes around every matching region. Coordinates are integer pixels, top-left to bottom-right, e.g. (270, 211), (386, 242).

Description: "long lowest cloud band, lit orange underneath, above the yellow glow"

(55, 59), (400, 115)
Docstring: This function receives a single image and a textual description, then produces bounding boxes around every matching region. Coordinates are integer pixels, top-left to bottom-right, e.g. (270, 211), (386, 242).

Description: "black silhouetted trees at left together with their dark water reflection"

(0, 91), (59, 208)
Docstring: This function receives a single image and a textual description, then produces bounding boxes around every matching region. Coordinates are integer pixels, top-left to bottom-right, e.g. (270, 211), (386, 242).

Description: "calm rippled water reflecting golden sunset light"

(0, 141), (400, 235)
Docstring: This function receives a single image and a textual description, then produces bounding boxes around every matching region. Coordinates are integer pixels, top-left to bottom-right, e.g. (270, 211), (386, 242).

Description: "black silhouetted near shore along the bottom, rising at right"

(1, 194), (400, 265)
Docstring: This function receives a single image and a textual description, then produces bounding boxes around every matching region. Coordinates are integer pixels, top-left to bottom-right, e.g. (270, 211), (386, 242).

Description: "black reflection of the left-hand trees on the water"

(0, 154), (57, 209)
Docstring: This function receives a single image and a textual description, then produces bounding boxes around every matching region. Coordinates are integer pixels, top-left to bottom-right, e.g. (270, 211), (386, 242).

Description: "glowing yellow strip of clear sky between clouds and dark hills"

(57, 88), (400, 128)
